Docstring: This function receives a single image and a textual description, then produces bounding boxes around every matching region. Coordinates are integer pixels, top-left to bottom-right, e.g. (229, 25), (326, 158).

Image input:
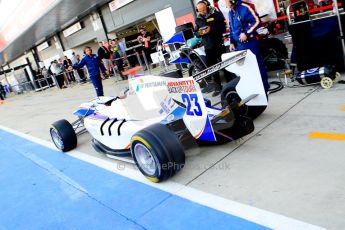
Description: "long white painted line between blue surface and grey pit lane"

(0, 125), (325, 230)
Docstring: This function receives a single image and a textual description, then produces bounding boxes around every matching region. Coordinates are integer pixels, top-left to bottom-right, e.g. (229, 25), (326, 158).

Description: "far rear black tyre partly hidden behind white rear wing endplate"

(221, 77), (267, 120)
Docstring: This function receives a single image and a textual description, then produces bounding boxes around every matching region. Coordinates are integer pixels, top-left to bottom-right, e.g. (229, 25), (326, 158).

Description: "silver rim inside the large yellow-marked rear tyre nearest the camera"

(134, 143), (157, 176)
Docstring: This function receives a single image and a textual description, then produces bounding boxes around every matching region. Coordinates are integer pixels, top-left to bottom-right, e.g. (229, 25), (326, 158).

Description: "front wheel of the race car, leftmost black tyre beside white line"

(50, 120), (78, 152)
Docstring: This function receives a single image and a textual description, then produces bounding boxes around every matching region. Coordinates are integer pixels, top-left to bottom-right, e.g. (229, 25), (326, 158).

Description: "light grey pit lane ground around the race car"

(0, 74), (345, 229)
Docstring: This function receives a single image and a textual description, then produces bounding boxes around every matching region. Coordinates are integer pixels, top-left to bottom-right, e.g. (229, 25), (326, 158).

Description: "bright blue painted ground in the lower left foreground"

(0, 130), (267, 230)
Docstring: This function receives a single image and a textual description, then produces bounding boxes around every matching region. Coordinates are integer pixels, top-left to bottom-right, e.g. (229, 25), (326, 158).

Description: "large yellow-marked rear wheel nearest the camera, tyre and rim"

(131, 124), (185, 183)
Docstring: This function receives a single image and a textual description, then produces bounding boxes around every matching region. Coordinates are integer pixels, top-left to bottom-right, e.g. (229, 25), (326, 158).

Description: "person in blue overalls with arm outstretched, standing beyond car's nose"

(69, 46), (109, 97)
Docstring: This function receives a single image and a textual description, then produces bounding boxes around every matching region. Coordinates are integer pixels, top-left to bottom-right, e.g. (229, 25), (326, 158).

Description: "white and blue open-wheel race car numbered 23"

(50, 51), (267, 182)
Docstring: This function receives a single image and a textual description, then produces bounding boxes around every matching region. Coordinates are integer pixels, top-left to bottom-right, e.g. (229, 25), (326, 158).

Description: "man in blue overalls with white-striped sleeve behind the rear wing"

(225, 0), (270, 92)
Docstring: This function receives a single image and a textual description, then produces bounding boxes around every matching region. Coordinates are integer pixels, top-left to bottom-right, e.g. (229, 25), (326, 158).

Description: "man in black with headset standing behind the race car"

(195, 0), (226, 97)
